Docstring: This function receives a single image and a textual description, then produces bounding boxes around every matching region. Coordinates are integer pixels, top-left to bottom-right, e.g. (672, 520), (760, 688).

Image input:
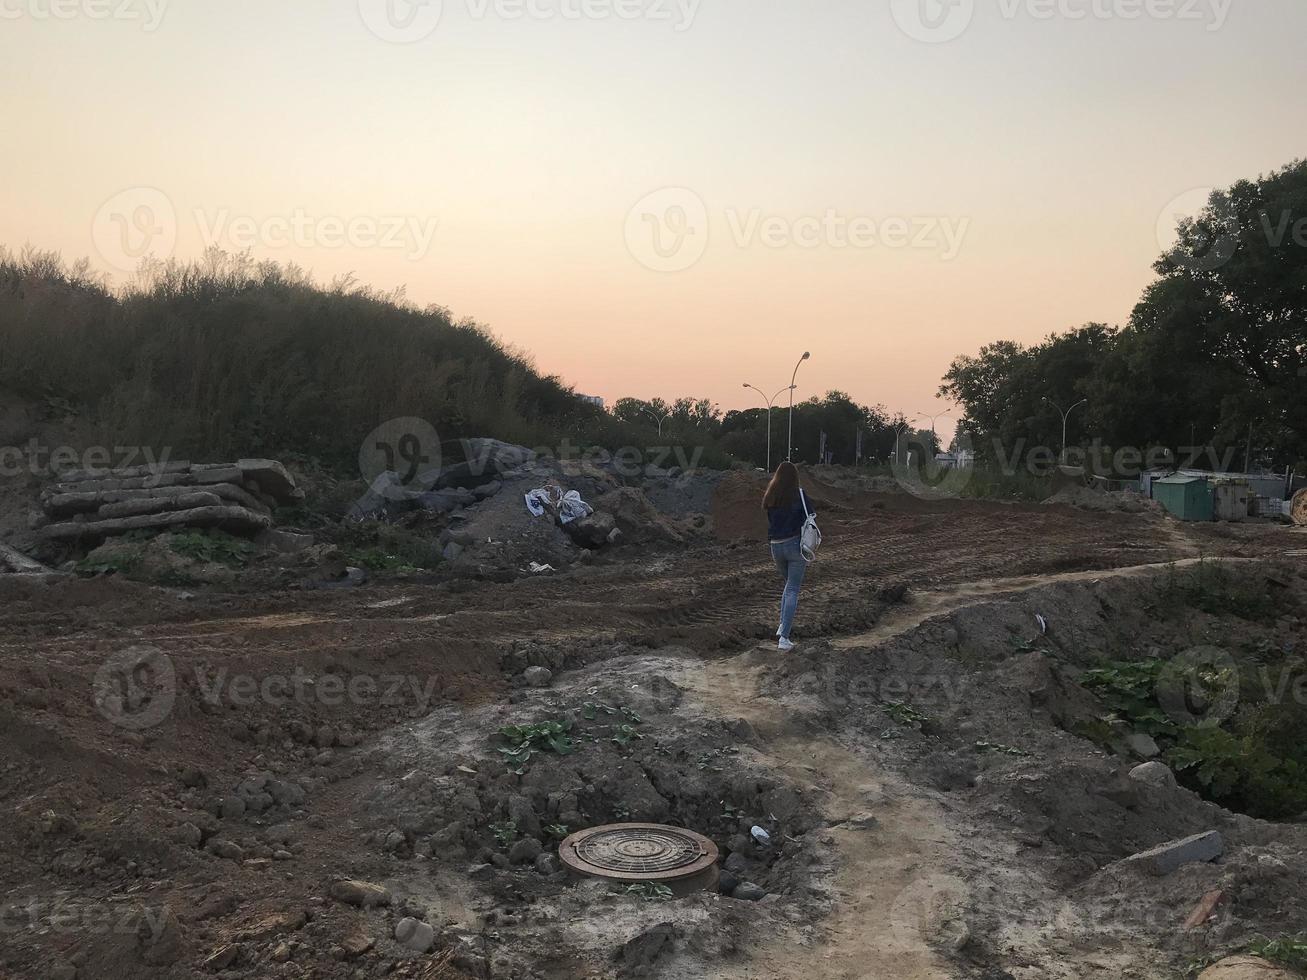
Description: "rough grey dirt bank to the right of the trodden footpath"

(758, 566), (1307, 976)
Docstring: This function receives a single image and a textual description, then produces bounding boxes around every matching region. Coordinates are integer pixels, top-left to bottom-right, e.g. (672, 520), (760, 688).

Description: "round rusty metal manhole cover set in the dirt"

(558, 823), (718, 891)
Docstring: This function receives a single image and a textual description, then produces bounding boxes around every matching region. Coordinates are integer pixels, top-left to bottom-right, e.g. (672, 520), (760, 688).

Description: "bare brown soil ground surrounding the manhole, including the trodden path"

(0, 474), (1307, 980)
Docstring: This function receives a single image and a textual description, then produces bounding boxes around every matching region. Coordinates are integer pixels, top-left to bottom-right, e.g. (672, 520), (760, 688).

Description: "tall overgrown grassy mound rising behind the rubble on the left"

(0, 250), (731, 472)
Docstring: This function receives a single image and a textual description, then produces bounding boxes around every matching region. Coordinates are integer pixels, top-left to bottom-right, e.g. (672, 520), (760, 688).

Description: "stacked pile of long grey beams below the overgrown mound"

(41, 460), (305, 541)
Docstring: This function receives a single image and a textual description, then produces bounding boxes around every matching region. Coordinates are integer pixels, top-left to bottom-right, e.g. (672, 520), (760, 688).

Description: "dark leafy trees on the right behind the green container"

(940, 161), (1307, 469)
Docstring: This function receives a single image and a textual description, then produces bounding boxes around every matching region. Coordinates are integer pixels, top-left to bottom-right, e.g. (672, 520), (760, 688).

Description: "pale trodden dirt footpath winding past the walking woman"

(676, 558), (1259, 980)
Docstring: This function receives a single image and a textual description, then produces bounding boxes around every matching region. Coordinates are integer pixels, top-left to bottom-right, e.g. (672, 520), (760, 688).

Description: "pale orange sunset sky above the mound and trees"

(0, 0), (1307, 416)
